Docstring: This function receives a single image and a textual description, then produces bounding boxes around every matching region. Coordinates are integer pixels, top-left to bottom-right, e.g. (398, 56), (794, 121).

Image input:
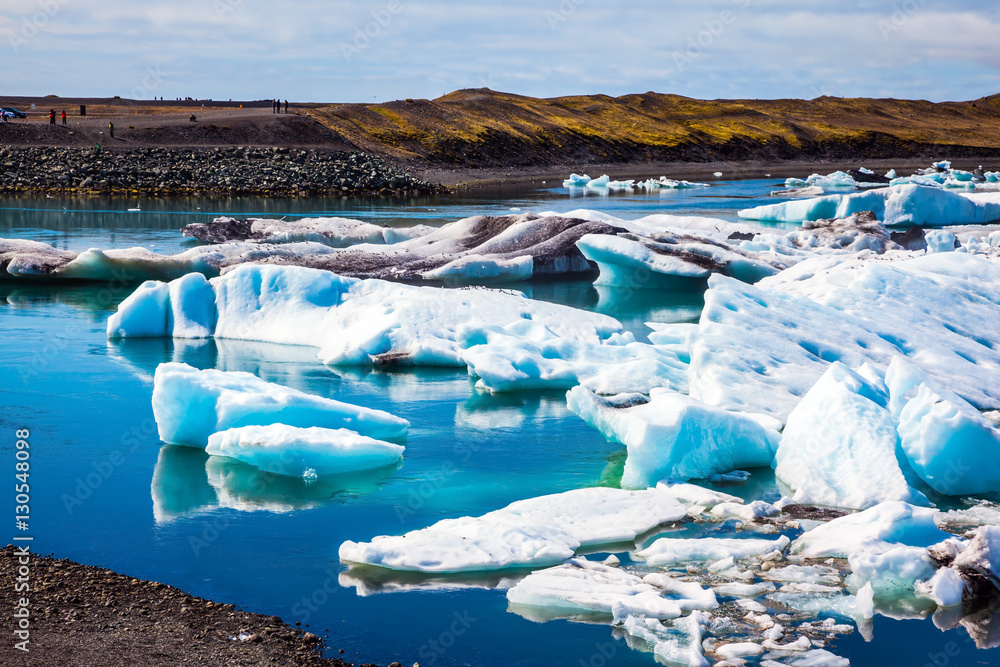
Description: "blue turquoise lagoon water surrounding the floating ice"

(0, 180), (1000, 667)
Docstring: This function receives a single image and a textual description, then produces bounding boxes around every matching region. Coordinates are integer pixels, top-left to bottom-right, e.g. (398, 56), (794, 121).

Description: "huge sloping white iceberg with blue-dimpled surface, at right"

(676, 253), (1000, 421)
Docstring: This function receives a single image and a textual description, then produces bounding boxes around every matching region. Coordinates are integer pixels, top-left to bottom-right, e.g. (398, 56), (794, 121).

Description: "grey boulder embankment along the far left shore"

(0, 146), (441, 197)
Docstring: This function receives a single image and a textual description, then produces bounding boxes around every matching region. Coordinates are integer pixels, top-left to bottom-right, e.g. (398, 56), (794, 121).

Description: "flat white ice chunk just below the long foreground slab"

(507, 558), (681, 619)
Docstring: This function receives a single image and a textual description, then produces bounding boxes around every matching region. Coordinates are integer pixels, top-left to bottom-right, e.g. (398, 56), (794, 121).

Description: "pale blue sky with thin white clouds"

(0, 0), (1000, 102)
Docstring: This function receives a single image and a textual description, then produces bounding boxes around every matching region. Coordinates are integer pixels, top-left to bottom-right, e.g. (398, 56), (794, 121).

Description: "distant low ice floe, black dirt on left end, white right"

(181, 217), (434, 248)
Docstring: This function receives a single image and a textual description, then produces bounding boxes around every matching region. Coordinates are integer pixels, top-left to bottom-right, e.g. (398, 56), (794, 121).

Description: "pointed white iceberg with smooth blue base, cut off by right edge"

(887, 358), (1000, 495)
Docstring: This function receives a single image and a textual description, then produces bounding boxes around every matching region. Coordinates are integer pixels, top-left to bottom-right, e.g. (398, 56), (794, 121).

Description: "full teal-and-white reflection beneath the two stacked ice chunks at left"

(151, 445), (398, 523)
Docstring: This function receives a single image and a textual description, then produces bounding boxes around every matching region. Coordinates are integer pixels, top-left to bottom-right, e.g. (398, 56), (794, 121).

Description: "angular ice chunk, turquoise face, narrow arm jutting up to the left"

(566, 387), (779, 488)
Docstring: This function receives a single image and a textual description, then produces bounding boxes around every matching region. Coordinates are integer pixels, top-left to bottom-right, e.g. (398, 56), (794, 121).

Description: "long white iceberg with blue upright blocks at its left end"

(107, 265), (621, 367)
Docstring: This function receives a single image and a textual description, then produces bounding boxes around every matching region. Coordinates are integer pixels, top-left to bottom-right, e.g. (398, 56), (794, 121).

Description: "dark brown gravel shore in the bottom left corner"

(0, 545), (386, 667)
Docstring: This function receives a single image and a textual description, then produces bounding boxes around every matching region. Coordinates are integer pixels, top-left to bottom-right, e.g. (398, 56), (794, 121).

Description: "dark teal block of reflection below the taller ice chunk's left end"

(150, 445), (219, 523)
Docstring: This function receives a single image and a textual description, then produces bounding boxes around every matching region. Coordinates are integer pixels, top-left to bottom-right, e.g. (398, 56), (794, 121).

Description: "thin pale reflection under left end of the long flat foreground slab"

(340, 565), (528, 597)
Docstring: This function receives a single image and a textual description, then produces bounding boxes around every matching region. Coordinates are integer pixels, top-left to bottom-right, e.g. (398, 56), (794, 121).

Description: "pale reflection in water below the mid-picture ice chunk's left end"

(455, 392), (569, 430)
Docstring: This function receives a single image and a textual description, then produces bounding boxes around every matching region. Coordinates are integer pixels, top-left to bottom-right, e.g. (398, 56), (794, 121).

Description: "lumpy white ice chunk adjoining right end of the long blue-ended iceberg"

(462, 320), (687, 394)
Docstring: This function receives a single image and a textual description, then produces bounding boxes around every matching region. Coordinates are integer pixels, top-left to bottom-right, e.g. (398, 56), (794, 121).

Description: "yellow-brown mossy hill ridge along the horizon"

(308, 88), (1000, 167)
